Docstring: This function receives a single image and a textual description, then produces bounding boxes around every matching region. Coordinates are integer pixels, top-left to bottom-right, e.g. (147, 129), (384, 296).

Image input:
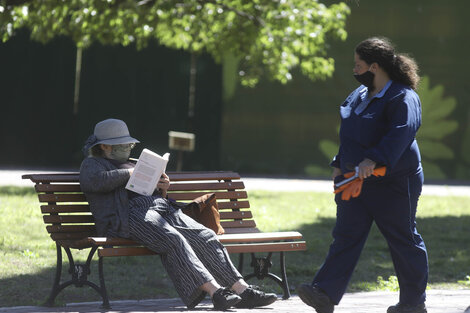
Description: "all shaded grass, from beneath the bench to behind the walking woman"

(0, 215), (470, 306)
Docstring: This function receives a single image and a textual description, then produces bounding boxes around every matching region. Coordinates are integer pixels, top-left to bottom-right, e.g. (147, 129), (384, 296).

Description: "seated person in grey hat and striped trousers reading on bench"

(80, 119), (277, 310)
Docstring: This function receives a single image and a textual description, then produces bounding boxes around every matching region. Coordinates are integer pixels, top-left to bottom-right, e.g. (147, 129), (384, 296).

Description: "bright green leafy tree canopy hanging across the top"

(0, 0), (350, 86)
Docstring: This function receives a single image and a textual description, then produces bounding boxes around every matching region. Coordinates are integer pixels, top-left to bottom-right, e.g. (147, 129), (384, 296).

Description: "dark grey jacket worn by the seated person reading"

(80, 157), (130, 238)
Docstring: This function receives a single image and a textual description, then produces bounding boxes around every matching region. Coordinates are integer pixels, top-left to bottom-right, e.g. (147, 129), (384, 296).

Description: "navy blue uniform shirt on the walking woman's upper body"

(331, 81), (421, 176)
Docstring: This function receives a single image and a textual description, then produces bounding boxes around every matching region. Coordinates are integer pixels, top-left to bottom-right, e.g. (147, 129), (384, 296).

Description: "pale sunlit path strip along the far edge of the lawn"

(0, 169), (470, 197)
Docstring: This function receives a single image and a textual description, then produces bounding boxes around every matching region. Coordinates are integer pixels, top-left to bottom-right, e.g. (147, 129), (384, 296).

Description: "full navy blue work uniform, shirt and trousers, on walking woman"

(313, 81), (428, 305)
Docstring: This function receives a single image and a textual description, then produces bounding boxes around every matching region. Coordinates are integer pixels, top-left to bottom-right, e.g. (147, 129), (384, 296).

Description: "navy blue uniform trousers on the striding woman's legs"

(313, 171), (428, 305)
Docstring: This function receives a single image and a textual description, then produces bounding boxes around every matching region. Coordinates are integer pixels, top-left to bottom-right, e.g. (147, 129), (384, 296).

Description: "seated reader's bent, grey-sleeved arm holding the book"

(80, 158), (130, 193)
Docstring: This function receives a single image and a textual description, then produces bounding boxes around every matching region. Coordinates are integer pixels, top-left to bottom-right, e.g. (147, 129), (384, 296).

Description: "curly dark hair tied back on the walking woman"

(356, 37), (420, 90)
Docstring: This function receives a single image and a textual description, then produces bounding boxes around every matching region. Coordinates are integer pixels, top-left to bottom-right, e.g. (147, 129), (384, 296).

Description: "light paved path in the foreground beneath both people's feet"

(0, 290), (470, 313)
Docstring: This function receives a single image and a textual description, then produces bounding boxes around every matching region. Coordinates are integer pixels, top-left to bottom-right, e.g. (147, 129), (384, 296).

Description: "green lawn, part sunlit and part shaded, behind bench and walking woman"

(0, 187), (470, 306)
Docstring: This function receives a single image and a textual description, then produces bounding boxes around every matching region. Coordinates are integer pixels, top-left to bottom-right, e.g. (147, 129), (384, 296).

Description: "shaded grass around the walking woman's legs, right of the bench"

(287, 215), (470, 291)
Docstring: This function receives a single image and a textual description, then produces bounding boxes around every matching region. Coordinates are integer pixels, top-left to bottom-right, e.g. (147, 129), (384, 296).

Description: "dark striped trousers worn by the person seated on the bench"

(129, 196), (243, 305)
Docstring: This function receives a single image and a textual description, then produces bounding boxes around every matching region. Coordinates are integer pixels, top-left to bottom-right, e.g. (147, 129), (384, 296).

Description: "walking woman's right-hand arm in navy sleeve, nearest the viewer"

(359, 92), (421, 177)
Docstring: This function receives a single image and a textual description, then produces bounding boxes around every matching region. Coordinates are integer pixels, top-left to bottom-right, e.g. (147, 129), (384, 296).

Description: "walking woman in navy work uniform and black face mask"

(298, 38), (428, 313)
